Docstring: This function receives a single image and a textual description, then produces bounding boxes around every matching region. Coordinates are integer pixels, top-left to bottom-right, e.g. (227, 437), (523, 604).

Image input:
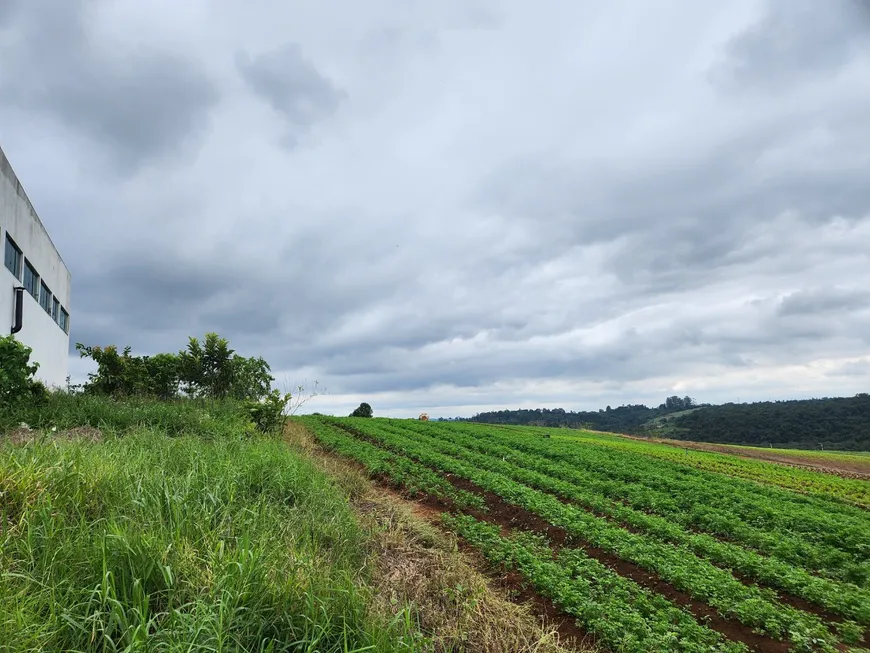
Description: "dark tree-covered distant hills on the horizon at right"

(466, 393), (870, 451)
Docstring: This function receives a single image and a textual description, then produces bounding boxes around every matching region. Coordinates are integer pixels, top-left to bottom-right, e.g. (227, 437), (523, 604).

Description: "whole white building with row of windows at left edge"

(0, 149), (70, 387)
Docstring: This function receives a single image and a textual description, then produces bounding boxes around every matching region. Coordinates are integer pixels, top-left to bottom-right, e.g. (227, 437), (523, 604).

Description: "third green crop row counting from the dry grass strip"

(380, 418), (870, 625)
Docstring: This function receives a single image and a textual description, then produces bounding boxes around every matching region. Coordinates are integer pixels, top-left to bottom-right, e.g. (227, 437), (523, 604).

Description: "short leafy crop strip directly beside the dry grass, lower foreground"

(444, 515), (748, 653)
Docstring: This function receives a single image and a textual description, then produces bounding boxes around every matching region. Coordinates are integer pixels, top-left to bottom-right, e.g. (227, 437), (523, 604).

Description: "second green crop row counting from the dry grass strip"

(328, 420), (861, 651)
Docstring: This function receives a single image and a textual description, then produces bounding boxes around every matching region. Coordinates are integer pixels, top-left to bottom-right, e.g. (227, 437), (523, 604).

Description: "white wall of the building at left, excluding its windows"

(0, 149), (72, 387)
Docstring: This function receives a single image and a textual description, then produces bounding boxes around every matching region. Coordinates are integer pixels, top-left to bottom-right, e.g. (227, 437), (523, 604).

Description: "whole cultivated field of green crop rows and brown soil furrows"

(298, 416), (870, 652)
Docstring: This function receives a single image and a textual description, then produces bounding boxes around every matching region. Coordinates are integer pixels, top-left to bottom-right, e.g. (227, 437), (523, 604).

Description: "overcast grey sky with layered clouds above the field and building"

(0, 0), (870, 416)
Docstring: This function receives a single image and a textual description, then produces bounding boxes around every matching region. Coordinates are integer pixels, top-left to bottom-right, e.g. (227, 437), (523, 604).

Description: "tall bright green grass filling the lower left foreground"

(0, 426), (426, 652)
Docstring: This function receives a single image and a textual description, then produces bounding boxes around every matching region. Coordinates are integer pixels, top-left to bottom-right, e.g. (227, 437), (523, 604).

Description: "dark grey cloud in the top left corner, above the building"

(0, 0), (218, 173)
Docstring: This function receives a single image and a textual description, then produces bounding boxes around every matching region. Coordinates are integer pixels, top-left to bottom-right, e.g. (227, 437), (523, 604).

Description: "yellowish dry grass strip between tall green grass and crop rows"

(285, 421), (590, 653)
